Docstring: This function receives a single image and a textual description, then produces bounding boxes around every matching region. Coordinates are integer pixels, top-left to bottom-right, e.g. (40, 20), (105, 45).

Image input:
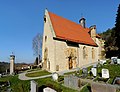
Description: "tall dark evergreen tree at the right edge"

(115, 4), (120, 57)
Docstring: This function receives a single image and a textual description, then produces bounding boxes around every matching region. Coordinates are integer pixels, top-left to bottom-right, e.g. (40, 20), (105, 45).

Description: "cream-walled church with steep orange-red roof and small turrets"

(42, 9), (104, 72)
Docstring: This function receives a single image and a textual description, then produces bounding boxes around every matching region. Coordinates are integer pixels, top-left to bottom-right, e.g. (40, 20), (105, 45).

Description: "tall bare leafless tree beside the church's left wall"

(32, 33), (42, 64)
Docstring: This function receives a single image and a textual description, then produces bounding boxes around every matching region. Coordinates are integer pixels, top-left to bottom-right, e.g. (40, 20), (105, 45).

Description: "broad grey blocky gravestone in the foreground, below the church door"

(64, 75), (80, 89)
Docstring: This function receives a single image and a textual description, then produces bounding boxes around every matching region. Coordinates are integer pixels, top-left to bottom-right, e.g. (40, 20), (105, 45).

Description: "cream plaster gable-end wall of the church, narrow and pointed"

(42, 10), (55, 71)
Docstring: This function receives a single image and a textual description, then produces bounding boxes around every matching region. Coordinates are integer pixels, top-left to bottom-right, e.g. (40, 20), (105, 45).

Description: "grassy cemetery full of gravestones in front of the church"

(0, 58), (120, 92)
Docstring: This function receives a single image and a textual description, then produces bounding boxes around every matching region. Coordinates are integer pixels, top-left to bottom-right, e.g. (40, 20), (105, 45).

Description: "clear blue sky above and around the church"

(0, 0), (120, 63)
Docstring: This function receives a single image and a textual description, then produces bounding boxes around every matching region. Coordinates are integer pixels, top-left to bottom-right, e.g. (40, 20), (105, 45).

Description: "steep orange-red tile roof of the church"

(48, 12), (97, 46)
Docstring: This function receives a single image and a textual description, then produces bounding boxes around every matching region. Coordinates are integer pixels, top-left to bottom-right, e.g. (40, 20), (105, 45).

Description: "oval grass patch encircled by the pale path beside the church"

(26, 70), (51, 77)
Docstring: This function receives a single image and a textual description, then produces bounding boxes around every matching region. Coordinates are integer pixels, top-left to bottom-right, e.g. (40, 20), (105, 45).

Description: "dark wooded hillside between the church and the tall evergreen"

(99, 28), (118, 58)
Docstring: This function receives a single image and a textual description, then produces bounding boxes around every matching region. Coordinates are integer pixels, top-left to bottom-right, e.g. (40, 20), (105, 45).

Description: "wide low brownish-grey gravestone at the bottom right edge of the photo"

(91, 83), (116, 92)
